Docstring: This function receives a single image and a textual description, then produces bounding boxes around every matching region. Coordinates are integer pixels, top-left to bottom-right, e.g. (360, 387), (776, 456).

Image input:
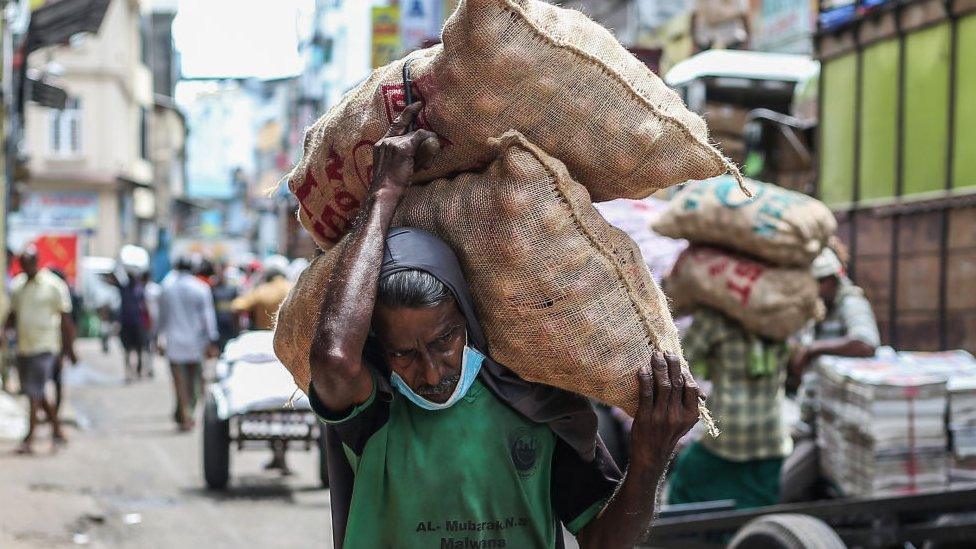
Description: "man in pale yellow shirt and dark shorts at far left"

(6, 247), (78, 454)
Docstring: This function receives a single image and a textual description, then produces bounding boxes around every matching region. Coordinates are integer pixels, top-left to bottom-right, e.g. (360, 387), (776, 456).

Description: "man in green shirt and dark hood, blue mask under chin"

(300, 103), (699, 547)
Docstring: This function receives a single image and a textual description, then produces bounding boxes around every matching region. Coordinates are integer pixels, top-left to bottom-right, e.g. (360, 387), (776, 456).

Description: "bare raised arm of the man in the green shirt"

(309, 102), (437, 413)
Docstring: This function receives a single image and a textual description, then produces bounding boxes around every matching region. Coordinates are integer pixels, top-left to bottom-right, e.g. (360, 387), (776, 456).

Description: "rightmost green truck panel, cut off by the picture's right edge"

(952, 14), (976, 188)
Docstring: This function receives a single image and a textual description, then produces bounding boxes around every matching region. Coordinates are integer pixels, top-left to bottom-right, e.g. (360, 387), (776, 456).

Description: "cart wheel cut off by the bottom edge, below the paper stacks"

(728, 513), (847, 549)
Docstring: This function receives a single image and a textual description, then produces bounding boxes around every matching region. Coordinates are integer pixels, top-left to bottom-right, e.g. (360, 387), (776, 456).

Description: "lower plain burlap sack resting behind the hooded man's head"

(275, 132), (681, 414)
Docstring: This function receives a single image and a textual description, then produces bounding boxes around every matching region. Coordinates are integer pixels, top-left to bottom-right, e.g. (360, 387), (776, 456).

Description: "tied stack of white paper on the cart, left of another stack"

(818, 353), (948, 496)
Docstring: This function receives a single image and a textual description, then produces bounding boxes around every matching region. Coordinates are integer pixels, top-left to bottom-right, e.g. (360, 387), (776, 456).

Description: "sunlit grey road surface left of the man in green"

(0, 340), (331, 548)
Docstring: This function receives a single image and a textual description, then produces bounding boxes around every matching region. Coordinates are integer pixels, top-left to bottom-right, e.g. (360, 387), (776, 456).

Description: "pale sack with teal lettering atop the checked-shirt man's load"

(653, 177), (837, 267)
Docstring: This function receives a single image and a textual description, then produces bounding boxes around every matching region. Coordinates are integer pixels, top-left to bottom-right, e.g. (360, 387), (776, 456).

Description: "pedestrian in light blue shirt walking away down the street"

(159, 258), (219, 431)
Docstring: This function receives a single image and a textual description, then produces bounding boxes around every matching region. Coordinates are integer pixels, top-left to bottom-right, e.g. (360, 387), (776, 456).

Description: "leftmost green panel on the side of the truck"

(820, 54), (857, 205)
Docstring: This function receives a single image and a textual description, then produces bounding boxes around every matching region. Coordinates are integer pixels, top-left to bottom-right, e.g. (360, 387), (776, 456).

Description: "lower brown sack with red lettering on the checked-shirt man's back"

(664, 245), (824, 340)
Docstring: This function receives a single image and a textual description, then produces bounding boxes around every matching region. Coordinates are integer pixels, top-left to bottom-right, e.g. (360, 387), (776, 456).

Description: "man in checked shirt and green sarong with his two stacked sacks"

(654, 178), (836, 508)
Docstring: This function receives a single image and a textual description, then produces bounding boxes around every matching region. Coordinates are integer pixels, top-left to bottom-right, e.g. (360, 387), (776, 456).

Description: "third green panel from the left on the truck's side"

(902, 23), (948, 195)
